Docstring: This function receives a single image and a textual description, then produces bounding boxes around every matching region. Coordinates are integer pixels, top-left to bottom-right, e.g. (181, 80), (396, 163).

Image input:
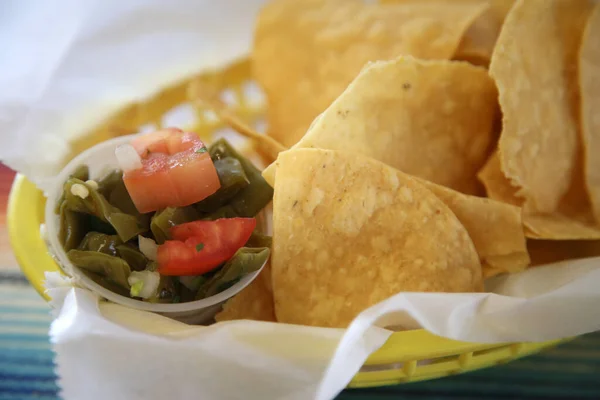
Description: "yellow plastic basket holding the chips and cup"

(8, 60), (561, 387)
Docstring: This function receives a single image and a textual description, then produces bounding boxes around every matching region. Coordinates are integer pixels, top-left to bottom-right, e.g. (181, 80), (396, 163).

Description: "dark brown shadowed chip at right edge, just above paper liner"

(527, 240), (600, 266)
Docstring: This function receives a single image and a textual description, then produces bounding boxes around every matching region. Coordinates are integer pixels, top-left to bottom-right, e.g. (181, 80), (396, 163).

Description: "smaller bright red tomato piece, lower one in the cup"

(157, 218), (256, 276)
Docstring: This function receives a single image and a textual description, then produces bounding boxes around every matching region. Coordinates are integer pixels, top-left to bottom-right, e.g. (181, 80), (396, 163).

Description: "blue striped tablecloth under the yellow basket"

(0, 166), (600, 400)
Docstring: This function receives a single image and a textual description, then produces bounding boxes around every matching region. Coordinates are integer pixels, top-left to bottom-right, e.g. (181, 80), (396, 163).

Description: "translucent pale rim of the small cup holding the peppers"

(44, 134), (269, 313)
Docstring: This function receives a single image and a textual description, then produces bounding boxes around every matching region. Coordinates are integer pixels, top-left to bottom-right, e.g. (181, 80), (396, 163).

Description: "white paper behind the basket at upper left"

(0, 0), (265, 194)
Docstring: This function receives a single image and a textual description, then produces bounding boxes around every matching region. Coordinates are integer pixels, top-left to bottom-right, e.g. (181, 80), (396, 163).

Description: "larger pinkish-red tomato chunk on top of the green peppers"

(123, 128), (221, 213)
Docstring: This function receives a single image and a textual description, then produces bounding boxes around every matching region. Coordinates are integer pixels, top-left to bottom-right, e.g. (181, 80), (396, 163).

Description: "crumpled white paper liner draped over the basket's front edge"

(47, 258), (600, 400)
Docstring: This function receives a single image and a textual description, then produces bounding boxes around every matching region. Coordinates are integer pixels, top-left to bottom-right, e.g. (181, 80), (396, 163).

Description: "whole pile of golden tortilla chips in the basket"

(193, 0), (600, 327)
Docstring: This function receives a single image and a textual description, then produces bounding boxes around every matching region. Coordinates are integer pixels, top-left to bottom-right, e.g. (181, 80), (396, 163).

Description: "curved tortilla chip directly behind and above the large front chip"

(263, 56), (497, 193)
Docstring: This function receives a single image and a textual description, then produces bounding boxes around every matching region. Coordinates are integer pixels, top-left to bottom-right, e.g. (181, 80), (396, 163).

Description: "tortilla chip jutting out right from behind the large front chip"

(420, 180), (530, 278)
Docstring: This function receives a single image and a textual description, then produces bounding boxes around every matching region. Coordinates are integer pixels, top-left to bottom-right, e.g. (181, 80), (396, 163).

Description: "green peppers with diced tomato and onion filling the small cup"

(55, 128), (273, 303)
